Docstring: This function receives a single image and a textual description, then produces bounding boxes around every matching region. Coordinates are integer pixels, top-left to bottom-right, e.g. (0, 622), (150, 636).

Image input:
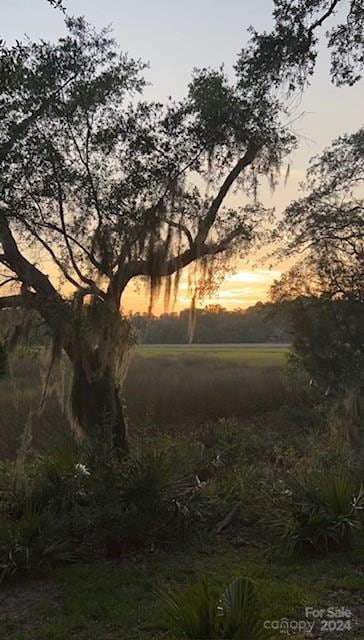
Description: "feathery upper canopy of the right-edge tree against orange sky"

(275, 129), (364, 303)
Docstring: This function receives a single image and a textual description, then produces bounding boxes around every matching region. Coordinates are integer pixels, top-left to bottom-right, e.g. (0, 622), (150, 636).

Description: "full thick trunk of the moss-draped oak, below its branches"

(34, 301), (130, 460)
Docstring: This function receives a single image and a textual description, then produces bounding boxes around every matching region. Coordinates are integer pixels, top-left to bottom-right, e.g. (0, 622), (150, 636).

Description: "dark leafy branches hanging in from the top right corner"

(238, 0), (364, 91)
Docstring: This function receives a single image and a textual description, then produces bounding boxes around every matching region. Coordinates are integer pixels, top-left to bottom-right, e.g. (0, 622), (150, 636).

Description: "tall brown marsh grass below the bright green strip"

(126, 355), (286, 427)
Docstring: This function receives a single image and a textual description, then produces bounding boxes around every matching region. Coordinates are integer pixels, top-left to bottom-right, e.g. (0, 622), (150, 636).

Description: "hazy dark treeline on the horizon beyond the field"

(132, 302), (290, 344)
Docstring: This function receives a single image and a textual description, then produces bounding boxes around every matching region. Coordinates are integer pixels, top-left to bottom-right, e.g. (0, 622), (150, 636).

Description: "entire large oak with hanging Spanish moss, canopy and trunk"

(0, 0), (362, 453)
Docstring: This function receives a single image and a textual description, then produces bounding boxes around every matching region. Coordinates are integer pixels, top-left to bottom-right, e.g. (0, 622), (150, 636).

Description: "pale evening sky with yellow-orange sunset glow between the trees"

(0, 0), (364, 312)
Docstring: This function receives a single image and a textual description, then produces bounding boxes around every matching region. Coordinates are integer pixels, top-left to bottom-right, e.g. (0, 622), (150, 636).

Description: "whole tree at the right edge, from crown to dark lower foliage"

(273, 129), (364, 441)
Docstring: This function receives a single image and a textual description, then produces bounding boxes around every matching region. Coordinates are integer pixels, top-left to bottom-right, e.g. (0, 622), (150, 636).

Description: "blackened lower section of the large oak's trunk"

(71, 366), (129, 459)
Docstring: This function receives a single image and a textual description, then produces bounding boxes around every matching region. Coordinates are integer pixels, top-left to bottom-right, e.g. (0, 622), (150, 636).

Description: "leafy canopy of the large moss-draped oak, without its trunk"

(0, 19), (293, 320)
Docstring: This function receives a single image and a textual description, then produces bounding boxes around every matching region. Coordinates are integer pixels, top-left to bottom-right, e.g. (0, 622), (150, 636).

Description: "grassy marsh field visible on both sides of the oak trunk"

(0, 345), (292, 459)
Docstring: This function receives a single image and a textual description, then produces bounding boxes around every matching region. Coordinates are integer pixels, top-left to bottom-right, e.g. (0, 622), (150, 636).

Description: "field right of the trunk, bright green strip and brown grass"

(125, 345), (288, 428)
